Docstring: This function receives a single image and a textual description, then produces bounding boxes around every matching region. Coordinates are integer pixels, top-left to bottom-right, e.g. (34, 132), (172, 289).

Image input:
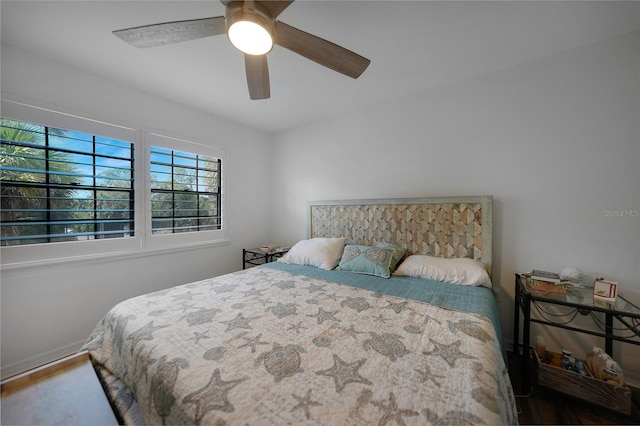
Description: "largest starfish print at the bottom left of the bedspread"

(182, 368), (247, 424)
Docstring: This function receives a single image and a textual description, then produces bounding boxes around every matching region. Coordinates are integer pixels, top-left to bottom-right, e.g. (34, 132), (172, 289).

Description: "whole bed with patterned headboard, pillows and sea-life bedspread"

(83, 196), (517, 425)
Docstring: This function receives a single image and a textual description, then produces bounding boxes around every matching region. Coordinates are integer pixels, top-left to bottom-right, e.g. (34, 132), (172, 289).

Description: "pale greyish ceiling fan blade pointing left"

(113, 16), (227, 47)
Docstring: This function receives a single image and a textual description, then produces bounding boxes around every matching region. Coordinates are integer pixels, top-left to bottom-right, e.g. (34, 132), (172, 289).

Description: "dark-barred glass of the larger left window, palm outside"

(0, 119), (134, 246)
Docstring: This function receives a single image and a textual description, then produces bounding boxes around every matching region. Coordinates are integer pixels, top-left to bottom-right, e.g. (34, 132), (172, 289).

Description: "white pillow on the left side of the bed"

(278, 238), (347, 271)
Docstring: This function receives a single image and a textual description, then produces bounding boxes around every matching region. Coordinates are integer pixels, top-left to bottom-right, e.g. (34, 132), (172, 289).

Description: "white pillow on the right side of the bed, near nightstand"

(393, 254), (491, 288)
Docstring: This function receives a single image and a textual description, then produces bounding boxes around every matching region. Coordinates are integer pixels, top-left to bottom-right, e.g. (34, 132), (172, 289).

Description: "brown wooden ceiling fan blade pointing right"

(275, 21), (371, 78)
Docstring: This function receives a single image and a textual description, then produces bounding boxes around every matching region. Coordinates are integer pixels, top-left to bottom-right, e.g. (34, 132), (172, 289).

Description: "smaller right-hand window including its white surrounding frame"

(144, 133), (226, 249)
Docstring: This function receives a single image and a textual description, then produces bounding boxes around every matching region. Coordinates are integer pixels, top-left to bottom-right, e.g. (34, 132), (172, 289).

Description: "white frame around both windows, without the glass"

(0, 99), (228, 270)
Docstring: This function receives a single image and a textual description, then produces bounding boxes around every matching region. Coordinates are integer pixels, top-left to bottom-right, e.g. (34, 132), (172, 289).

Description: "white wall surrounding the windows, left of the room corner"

(0, 44), (271, 377)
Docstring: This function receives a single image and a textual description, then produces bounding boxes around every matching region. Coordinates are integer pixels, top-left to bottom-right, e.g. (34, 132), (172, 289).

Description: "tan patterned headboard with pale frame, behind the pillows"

(308, 195), (493, 275)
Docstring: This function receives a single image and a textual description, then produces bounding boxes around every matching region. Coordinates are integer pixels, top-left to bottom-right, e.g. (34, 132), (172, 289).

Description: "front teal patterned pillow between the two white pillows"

(338, 245), (393, 278)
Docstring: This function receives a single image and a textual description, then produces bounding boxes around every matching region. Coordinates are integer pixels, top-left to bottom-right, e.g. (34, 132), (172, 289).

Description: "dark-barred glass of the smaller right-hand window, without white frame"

(151, 146), (222, 234)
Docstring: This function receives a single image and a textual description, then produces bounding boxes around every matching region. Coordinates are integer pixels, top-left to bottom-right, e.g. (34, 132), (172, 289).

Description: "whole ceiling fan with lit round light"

(113, 0), (371, 100)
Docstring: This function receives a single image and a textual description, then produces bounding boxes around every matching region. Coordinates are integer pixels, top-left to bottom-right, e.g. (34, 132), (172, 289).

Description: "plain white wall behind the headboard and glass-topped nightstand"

(271, 32), (640, 380)
